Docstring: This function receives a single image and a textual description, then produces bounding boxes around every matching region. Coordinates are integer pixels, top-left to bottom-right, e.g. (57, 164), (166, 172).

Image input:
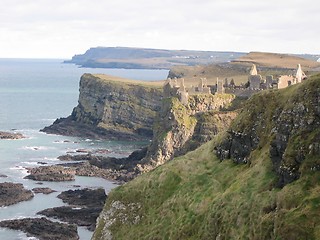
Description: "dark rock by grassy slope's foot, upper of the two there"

(58, 188), (107, 207)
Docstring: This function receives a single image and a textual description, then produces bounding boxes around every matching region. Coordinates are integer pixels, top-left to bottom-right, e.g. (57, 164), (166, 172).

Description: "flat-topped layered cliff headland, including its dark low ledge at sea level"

(43, 74), (162, 140)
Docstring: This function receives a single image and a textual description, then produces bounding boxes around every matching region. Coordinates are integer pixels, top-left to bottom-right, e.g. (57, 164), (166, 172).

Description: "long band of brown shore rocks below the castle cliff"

(25, 148), (147, 184)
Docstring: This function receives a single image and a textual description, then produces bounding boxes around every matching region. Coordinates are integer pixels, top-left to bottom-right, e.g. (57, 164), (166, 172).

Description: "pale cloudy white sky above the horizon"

(0, 0), (320, 59)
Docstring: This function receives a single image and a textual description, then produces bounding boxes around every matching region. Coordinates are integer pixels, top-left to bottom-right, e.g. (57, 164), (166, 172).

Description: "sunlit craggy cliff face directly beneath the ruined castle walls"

(140, 94), (236, 171)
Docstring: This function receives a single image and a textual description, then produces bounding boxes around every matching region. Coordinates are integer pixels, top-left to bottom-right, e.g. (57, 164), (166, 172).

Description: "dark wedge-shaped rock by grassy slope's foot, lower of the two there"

(37, 206), (102, 231)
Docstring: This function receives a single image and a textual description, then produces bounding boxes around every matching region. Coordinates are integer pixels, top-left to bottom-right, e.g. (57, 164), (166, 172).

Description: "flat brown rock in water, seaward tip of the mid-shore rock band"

(25, 165), (75, 182)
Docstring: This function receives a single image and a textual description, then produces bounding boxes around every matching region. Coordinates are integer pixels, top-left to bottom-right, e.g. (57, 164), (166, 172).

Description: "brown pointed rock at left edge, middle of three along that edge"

(0, 182), (34, 206)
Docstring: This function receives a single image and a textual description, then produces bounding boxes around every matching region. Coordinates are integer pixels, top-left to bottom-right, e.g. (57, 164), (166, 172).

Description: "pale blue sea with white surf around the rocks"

(0, 59), (168, 240)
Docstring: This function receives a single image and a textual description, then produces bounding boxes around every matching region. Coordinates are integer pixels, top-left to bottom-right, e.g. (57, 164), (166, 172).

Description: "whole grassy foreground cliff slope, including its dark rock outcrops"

(93, 75), (320, 240)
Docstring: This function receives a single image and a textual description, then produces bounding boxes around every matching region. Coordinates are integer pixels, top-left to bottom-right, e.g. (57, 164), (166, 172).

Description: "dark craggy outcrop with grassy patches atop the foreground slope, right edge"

(216, 73), (320, 187)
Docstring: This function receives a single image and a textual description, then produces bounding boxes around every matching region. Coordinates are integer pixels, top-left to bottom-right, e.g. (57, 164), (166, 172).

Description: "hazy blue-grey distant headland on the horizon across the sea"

(65, 47), (244, 69)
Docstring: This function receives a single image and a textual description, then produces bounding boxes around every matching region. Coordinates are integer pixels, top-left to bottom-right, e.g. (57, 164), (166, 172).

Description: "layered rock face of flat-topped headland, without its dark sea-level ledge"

(72, 74), (162, 137)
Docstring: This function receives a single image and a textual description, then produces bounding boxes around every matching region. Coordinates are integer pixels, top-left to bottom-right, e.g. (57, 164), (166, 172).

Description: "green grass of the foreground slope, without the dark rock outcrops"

(93, 75), (320, 240)
